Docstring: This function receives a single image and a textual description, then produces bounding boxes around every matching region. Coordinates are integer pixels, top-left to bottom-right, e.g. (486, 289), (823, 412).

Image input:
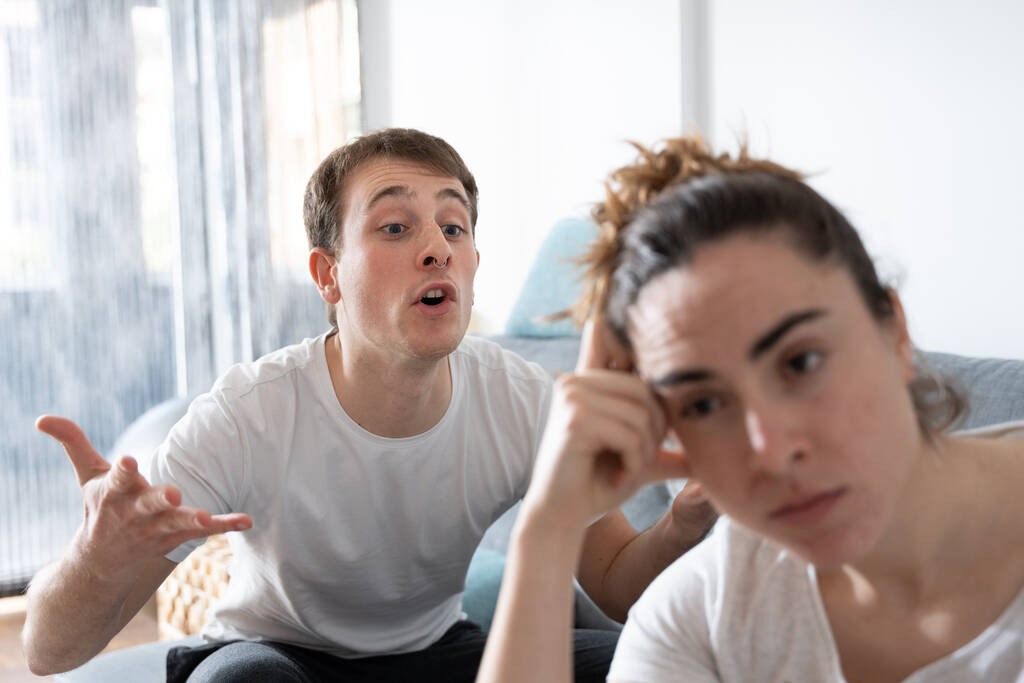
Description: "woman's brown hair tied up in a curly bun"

(572, 136), (964, 434)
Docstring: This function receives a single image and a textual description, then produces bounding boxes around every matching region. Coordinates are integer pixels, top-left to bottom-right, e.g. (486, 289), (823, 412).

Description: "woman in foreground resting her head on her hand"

(478, 138), (1024, 683)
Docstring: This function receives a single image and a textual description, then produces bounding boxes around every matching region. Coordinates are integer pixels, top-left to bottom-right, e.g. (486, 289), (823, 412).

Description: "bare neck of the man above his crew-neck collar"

(325, 334), (452, 438)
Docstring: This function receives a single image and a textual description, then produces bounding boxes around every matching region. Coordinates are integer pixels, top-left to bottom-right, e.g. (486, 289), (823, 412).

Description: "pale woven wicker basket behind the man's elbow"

(157, 535), (231, 640)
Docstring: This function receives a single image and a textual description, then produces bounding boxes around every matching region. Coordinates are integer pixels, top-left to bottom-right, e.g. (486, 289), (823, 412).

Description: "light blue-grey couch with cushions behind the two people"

(56, 219), (1024, 683)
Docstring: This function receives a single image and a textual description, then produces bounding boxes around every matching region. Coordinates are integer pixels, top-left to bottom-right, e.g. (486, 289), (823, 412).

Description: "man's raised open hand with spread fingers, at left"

(36, 415), (252, 581)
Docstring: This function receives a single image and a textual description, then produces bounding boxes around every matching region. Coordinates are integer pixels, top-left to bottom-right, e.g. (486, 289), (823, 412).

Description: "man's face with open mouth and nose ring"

(336, 158), (479, 358)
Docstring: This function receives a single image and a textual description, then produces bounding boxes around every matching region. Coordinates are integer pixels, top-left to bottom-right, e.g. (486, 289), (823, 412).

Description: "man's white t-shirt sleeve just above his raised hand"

(145, 393), (247, 562)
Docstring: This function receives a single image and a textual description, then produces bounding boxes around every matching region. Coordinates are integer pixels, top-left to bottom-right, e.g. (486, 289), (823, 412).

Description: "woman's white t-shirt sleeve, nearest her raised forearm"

(608, 535), (719, 683)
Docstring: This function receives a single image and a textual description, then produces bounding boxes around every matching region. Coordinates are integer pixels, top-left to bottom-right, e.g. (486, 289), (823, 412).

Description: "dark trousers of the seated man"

(167, 622), (618, 683)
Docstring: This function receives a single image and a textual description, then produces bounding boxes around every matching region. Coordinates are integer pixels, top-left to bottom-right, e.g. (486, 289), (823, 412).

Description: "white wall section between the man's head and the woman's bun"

(359, 0), (700, 332)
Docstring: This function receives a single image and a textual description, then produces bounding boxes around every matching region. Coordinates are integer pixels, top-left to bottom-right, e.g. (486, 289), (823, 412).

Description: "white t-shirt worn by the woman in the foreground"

(608, 423), (1024, 683)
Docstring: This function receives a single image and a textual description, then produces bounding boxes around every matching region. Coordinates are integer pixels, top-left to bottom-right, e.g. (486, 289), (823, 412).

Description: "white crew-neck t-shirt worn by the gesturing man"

(147, 335), (552, 656)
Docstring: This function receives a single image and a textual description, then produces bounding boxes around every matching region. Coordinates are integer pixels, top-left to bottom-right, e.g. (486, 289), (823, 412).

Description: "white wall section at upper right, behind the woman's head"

(710, 0), (1024, 358)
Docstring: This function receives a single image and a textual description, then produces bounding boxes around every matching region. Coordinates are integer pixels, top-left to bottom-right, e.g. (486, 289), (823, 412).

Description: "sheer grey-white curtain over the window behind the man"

(0, 0), (359, 594)
